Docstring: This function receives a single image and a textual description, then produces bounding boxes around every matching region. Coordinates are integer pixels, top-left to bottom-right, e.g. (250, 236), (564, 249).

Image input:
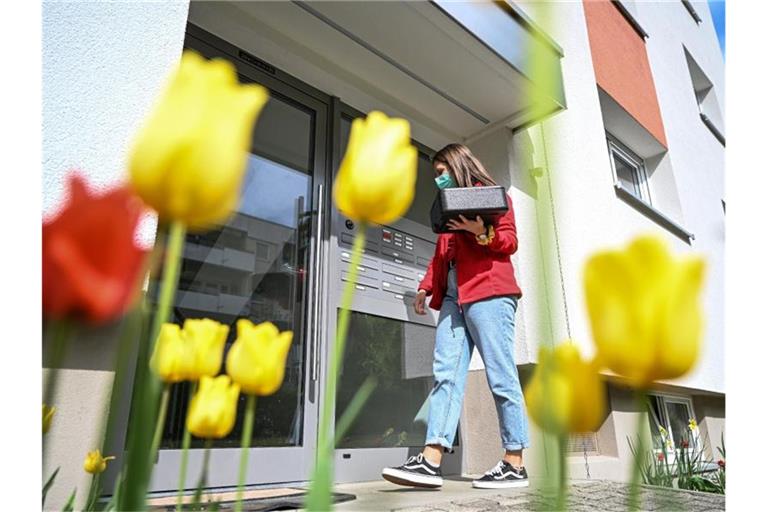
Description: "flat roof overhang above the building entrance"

(189, 0), (565, 148)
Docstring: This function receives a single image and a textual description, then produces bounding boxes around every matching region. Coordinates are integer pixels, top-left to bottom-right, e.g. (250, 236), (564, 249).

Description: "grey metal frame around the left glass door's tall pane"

(149, 27), (333, 493)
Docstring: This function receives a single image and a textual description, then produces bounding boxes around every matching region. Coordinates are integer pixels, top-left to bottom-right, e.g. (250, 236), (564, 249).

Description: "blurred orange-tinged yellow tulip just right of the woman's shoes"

(525, 341), (605, 434)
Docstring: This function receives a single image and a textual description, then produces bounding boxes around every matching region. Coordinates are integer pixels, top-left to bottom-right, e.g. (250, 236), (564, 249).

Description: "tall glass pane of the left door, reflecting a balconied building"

(158, 97), (314, 448)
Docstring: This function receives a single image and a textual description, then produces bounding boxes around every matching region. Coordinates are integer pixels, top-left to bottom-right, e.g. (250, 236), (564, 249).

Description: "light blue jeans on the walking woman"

(425, 269), (529, 450)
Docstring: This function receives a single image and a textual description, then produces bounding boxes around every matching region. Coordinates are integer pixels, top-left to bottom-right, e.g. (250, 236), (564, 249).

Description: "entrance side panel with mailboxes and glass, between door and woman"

(328, 104), (462, 482)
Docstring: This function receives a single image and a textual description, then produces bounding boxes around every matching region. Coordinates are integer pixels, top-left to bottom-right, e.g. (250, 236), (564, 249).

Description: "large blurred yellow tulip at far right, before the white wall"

(584, 237), (704, 389)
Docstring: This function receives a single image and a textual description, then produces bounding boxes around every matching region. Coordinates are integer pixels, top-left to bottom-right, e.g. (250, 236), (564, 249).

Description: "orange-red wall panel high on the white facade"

(584, 0), (667, 147)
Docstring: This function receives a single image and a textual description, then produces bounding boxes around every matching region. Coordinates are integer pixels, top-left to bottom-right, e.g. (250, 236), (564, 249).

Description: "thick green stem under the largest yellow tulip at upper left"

(118, 221), (186, 510)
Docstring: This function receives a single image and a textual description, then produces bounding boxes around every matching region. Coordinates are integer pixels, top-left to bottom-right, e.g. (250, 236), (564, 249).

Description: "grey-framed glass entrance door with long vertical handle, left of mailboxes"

(152, 34), (327, 491)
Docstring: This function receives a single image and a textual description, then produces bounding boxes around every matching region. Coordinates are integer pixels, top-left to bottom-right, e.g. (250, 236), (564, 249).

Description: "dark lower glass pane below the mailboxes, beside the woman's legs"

(336, 312), (458, 448)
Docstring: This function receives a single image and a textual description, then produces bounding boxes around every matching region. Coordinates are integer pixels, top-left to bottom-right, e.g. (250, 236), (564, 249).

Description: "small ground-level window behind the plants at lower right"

(648, 395), (700, 455)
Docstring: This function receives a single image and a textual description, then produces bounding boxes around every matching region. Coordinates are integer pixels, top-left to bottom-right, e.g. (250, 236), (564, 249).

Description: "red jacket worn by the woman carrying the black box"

(419, 195), (522, 310)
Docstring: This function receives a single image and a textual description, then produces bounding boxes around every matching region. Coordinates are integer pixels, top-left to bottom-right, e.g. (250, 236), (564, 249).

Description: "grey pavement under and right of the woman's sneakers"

(335, 477), (725, 512)
